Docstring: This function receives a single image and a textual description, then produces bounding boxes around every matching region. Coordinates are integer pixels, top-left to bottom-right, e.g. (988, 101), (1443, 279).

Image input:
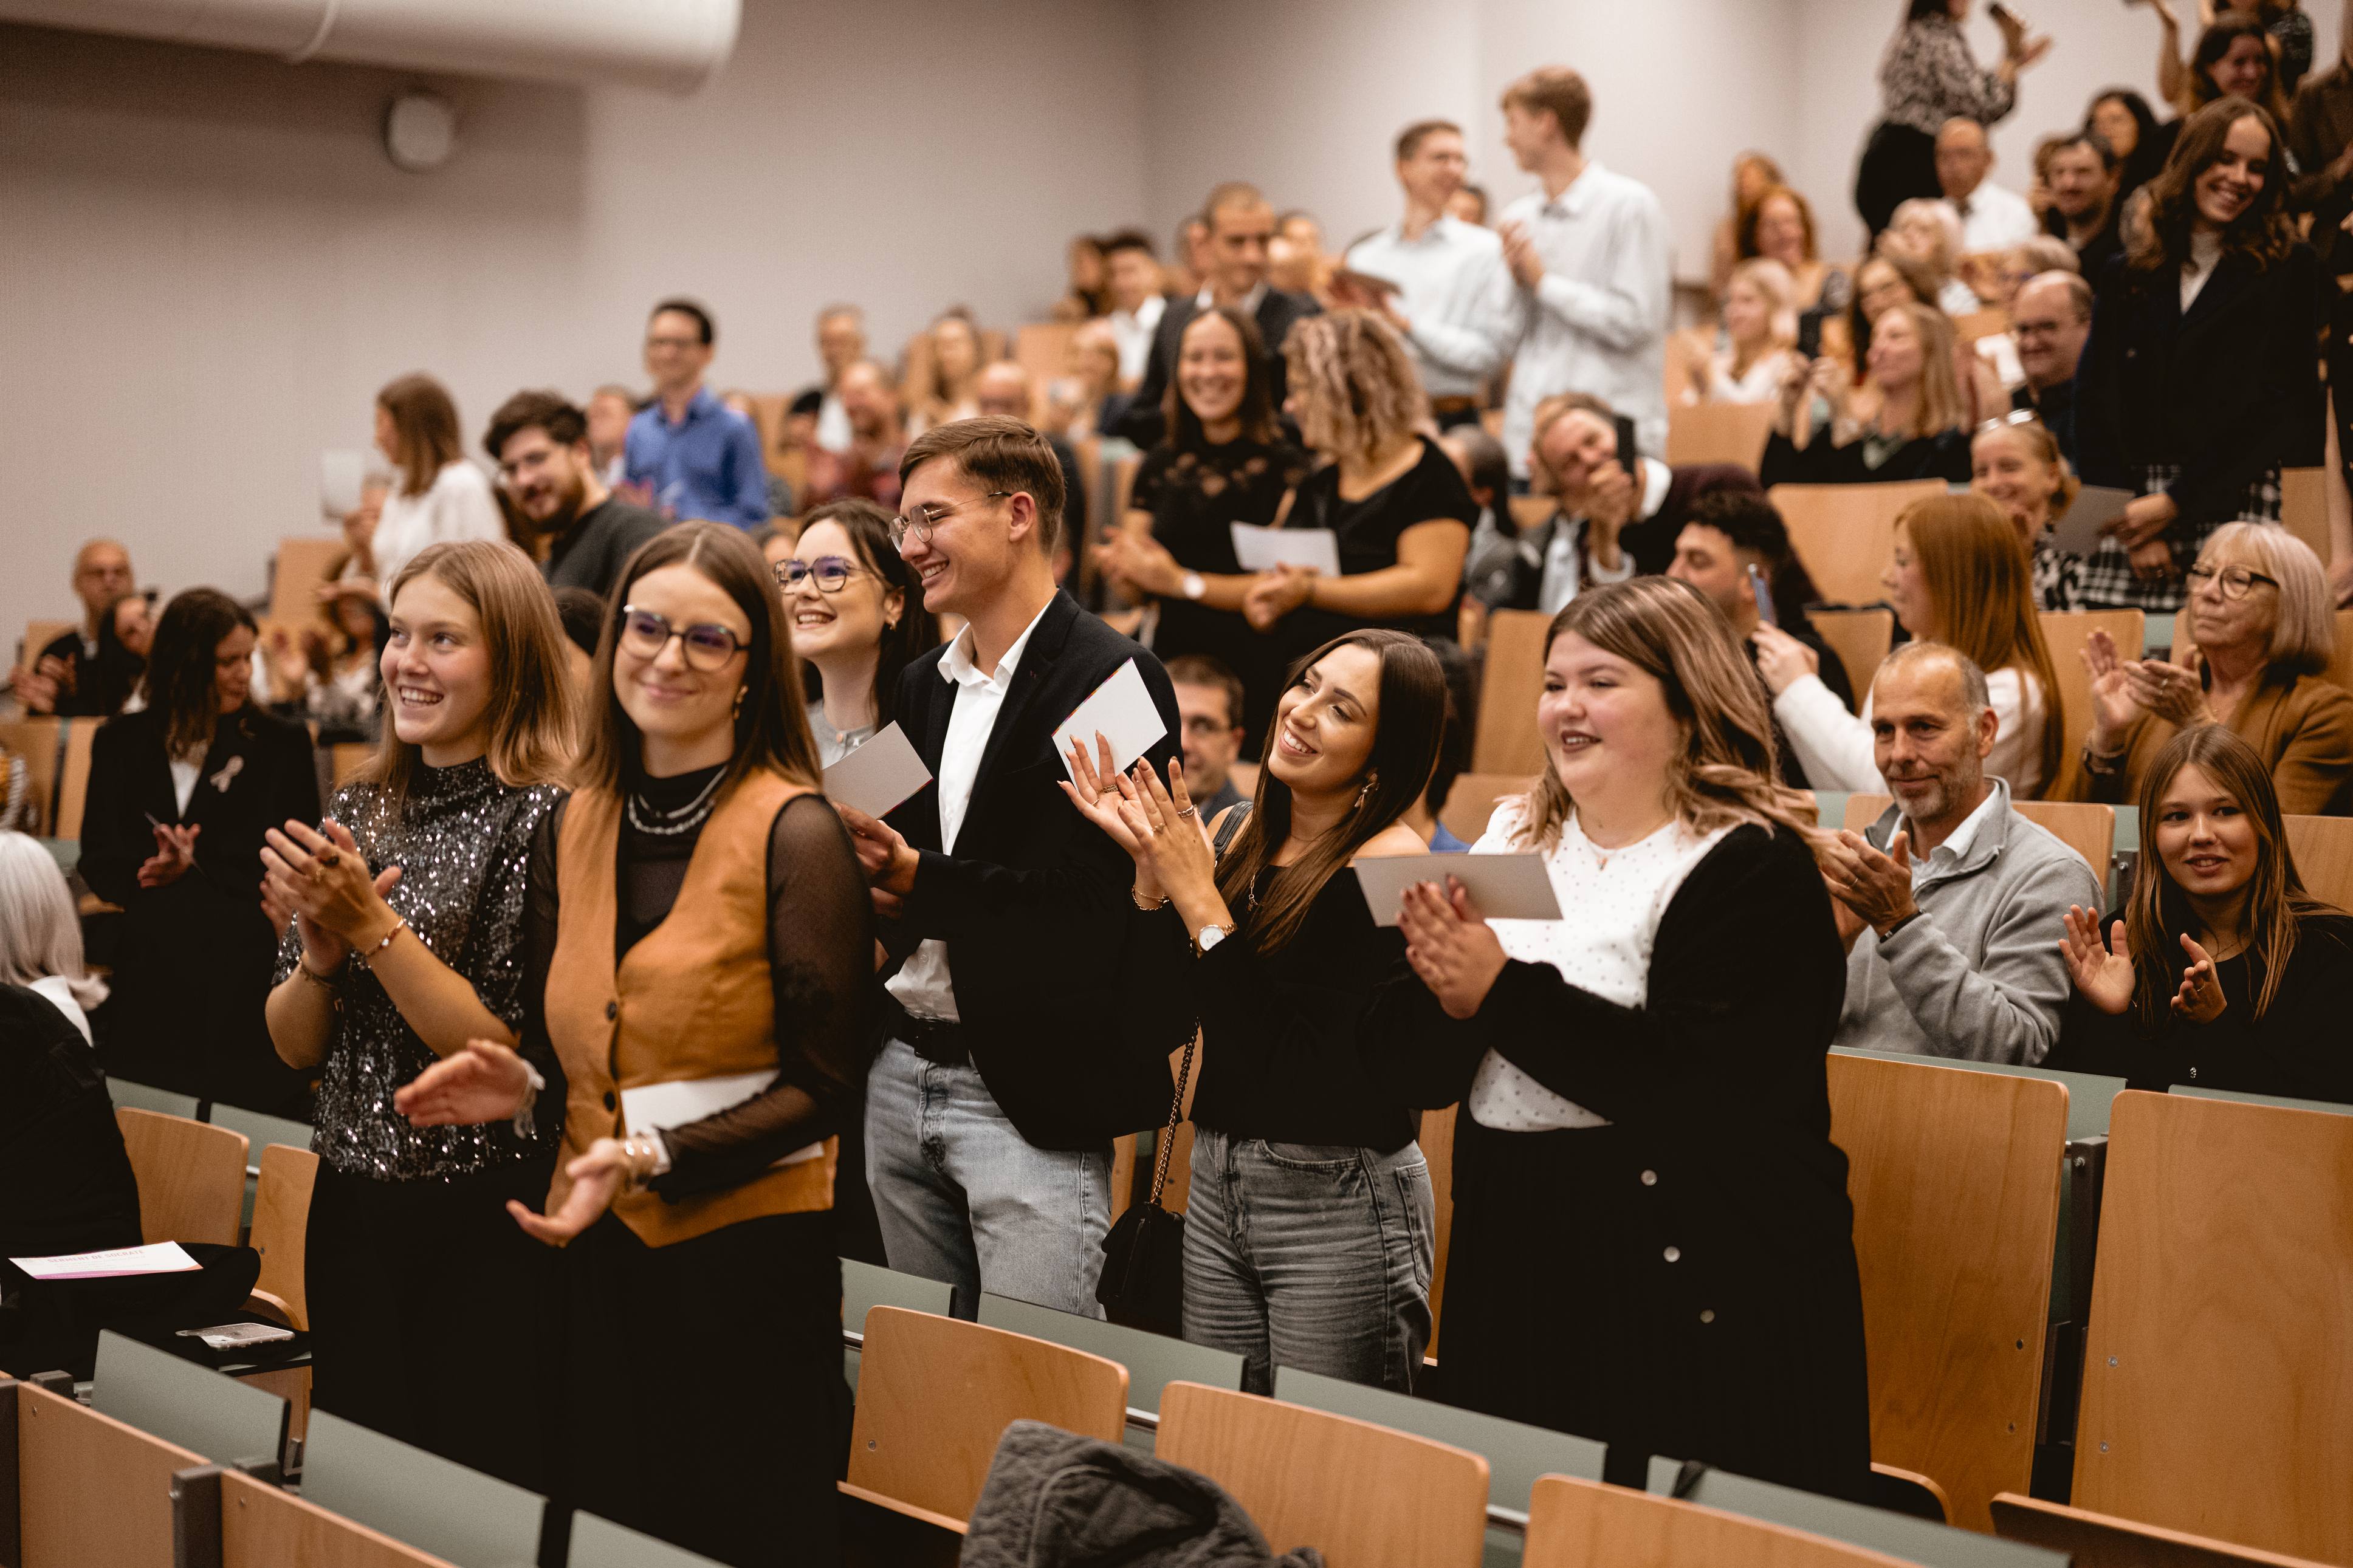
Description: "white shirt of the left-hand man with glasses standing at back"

(1348, 219), (1516, 397)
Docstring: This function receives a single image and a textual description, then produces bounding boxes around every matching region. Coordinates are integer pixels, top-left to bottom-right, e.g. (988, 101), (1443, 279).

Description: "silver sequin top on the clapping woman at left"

(278, 759), (562, 1182)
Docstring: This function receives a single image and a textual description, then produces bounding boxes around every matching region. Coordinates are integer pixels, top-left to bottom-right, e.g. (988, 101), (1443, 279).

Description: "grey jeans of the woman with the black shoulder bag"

(1184, 1126), (1438, 1394)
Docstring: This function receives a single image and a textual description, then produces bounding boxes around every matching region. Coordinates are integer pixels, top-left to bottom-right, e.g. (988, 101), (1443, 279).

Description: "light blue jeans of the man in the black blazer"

(866, 1039), (1111, 1319)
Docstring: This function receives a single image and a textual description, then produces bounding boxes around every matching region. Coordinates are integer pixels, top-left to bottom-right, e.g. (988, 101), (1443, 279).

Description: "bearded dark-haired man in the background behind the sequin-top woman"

(483, 392), (671, 595)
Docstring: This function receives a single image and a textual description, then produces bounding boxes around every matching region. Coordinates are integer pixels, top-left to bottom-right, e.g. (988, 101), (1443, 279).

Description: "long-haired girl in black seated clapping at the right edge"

(2047, 724), (2353, 1100)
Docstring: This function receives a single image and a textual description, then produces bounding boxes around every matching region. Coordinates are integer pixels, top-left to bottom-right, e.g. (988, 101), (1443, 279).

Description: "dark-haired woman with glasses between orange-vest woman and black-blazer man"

(777, 501), (939, 769)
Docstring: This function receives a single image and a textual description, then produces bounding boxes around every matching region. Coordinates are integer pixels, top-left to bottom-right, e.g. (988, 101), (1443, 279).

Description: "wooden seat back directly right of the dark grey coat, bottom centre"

(1153, 1382), (1487, 1568)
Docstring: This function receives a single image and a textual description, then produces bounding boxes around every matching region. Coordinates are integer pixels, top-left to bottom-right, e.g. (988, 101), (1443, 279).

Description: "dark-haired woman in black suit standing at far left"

(80, 587), (318, 1114)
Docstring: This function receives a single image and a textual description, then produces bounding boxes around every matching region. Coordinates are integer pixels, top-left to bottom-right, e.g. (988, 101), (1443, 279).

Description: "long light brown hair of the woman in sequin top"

(358, 538), (577, 802)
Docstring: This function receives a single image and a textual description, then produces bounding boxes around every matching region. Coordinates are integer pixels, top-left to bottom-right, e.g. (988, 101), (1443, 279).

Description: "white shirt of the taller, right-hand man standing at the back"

(1503, 162), (1671, 478)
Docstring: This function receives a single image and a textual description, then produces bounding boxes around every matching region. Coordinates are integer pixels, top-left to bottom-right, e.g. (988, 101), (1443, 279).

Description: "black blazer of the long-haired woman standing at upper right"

(2075, 244), (2323, 524)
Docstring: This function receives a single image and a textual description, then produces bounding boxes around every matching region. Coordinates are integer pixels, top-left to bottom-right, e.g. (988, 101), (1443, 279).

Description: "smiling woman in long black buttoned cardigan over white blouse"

(1365, 576), (1870, 1498)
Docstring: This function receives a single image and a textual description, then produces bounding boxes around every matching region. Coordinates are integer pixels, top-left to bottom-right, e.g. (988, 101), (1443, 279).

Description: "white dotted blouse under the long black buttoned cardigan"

(1463, 799), (1732, 1133)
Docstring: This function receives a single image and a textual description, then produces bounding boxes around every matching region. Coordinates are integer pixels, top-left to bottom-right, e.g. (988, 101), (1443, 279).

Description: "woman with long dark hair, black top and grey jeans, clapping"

(1063, 630), (1447, 1394)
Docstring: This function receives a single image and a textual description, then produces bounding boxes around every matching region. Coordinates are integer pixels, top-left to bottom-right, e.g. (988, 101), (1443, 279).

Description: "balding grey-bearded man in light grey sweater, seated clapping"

(1816, 642), (2106, 1067)
